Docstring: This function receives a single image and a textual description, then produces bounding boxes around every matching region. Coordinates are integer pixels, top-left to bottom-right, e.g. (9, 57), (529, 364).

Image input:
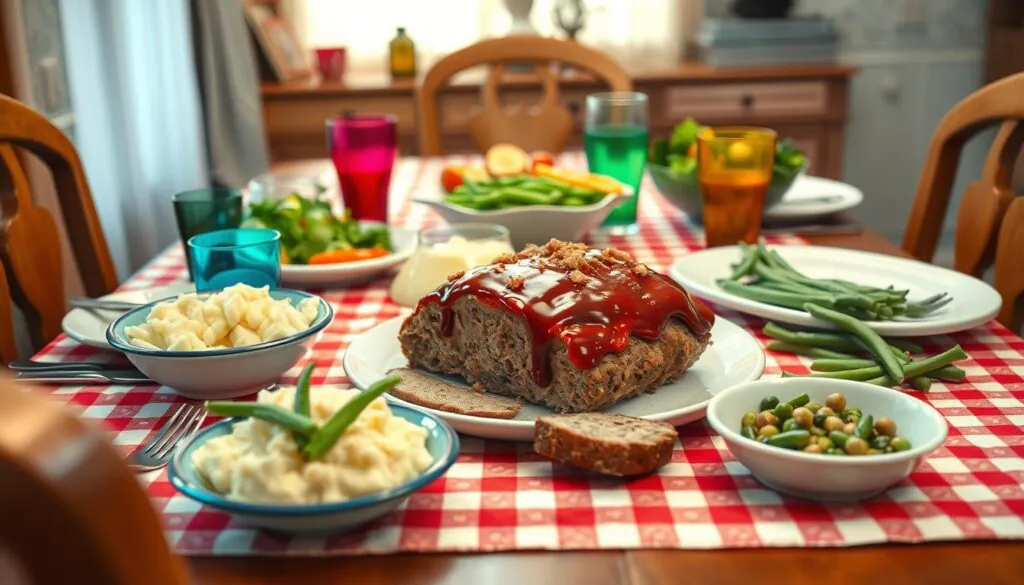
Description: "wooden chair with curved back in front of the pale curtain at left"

(0, 95), (118, 356)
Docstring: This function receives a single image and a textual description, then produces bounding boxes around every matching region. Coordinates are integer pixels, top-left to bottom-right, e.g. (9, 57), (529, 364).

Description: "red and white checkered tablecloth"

(32, 158), (1024, 555)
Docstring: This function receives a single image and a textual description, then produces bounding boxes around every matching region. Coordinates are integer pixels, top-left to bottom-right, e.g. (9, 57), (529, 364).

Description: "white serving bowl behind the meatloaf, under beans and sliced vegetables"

(415, 181), (633, 249)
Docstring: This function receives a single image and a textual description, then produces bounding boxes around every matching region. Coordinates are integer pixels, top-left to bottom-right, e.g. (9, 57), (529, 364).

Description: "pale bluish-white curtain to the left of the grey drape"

(60, 0), (210, 278)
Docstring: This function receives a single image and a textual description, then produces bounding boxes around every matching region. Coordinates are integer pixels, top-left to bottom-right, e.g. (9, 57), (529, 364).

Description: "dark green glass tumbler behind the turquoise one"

(171, 187), (242, 280)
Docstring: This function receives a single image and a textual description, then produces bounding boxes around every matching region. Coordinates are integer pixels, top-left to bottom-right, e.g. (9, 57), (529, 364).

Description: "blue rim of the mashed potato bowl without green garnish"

(106, 289), (334, 358)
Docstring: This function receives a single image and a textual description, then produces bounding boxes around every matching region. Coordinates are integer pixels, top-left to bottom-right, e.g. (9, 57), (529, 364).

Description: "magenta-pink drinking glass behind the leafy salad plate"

(327, 114), (398, 222)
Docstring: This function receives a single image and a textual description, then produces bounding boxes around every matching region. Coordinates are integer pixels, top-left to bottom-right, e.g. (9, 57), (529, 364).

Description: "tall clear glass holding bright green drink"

(584, 91), (648, 235)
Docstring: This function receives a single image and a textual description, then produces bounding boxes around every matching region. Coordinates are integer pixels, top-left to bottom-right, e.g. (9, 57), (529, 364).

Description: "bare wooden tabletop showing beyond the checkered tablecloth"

(176, 161), (1024, 585)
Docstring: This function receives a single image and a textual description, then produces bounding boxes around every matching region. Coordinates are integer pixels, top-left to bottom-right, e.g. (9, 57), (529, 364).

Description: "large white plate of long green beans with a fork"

(670, 244), (1001, 337)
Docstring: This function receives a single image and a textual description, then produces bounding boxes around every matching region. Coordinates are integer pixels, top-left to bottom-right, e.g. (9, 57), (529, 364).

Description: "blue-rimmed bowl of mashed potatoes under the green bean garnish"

(168, 386), (459, 534)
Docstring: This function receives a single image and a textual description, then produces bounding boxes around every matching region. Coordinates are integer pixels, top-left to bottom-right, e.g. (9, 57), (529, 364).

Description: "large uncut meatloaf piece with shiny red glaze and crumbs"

(399, 240), (715, 413)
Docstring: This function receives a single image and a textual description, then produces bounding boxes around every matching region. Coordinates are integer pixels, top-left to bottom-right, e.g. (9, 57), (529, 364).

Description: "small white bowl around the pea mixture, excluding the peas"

(708, 378), (947, 502)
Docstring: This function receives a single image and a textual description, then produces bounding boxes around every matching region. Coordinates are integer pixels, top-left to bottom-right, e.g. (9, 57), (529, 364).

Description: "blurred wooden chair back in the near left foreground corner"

(0, 377), (187, 585)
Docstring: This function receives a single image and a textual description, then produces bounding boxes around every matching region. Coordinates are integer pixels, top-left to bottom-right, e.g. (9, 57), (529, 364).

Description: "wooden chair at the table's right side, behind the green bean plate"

(903, 73), (1024, 330)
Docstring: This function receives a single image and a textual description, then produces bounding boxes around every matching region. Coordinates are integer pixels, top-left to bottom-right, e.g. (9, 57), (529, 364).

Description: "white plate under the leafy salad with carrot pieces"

(281, 227), (416, 288)
